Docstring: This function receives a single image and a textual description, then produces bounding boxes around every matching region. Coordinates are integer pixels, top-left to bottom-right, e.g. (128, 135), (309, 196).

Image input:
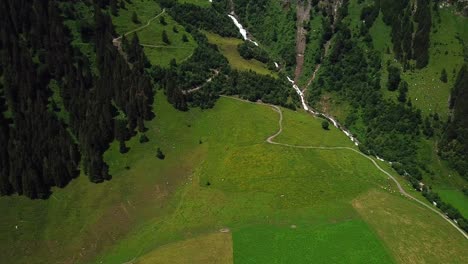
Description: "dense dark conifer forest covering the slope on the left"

(0, 0), (153, 198)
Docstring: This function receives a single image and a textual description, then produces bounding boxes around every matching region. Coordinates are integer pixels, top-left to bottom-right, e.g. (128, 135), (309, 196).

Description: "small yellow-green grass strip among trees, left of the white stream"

(204, 32), (276, 76)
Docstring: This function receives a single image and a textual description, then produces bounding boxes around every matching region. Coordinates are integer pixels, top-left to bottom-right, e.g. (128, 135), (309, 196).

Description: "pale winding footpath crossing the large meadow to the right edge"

(221, 95), (468, 239)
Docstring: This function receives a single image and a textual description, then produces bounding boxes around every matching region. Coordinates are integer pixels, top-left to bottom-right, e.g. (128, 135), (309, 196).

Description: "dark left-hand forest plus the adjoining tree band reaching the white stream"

(0, 0), (297, 198)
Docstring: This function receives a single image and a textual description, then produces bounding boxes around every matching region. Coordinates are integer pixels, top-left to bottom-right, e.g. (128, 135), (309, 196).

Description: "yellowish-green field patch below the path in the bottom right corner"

(353, 190), (468, 263)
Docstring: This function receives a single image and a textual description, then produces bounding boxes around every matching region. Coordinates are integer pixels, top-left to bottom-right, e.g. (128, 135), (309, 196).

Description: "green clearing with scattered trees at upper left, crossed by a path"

(113, 0), (197, 66)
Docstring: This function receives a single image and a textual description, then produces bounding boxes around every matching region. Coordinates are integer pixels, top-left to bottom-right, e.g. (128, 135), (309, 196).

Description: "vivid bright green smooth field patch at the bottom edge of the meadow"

(233, 220), (393, 264)
